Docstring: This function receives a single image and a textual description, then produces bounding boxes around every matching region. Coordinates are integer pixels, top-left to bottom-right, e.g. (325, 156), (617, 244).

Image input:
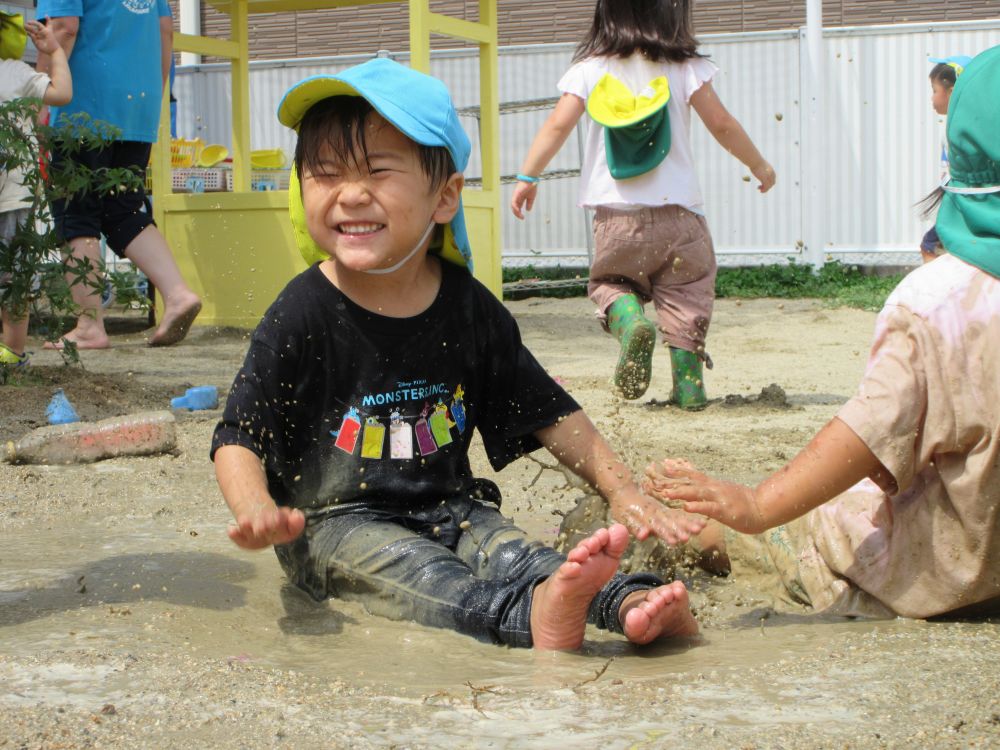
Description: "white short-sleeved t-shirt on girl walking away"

(559, 55), (718, 214)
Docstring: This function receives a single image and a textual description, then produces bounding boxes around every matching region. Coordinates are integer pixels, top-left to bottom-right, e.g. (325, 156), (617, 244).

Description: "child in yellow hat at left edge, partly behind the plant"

(0, 13), (73, 367)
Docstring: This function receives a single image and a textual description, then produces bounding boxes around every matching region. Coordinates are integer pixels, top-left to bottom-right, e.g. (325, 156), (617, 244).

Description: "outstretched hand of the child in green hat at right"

(643, 458), (768, 534)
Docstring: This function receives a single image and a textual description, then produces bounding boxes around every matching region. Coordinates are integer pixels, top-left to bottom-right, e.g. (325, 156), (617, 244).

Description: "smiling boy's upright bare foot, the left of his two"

(531, 523), (629, 651)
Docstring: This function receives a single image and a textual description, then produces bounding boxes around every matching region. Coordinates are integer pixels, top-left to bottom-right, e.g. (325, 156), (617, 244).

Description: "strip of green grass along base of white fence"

(503, 261), (904, 310)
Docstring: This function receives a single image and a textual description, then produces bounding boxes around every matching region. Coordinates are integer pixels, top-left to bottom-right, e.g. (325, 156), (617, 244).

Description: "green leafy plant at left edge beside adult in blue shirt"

(0, 99), (142, 374)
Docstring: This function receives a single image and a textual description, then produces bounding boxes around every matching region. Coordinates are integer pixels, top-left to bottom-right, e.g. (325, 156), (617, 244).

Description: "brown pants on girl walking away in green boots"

(587, 206), (716, 352)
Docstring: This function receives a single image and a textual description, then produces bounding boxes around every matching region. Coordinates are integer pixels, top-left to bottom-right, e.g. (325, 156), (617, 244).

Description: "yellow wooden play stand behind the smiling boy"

(151, 0), (501, 328)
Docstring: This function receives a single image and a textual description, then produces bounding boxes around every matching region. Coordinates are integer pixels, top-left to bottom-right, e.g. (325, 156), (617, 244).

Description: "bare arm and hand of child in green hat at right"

(646, 418), (895, 534)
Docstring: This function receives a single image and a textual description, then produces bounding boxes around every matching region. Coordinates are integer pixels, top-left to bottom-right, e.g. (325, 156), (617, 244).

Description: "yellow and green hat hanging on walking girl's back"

(587, 73), (670, 180)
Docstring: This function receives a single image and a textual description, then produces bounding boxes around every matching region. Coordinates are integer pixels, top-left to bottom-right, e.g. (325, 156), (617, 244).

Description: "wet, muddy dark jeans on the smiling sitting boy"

(275, 482), (662, 647)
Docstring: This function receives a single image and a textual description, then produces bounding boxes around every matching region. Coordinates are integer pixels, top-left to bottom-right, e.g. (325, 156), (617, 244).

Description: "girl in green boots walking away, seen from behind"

(511, 0), (775, 409)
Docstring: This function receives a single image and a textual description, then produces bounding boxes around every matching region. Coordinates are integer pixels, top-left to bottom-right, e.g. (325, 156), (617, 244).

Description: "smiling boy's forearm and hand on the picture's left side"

(215, 445), (306, 549)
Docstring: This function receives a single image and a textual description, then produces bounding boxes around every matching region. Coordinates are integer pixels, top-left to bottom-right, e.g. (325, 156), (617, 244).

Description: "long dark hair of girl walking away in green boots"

(573, 0), (704, 62)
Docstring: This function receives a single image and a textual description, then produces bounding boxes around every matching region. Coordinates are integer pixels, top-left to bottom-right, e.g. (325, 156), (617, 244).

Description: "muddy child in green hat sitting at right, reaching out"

(647, 46), (1000, 618)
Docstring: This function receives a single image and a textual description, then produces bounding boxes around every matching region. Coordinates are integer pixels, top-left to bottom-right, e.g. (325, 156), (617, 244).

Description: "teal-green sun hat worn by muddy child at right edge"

(937, 46), (1000, 278)
